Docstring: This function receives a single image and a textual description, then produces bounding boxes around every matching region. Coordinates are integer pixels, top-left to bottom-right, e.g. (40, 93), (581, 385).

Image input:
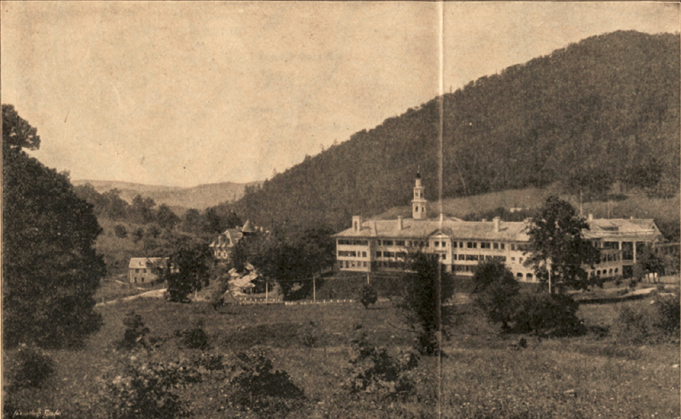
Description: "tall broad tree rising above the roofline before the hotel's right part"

(526, 196), (599, 291)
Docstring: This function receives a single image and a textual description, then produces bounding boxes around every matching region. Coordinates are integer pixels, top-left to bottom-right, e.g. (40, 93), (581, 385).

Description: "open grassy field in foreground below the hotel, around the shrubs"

(4, 290), (681, 418)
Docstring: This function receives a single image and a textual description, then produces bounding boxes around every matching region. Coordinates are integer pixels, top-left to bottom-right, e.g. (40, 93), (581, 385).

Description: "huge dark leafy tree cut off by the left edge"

(2, 105), (106, 347)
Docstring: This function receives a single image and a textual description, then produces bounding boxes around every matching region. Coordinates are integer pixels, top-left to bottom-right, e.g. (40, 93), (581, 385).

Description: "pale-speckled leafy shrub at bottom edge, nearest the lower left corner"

(102, 357), (189, 419)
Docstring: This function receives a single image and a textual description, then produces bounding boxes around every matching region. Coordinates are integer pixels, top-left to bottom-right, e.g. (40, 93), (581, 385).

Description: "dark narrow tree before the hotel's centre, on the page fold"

(397, 252), (454, 355)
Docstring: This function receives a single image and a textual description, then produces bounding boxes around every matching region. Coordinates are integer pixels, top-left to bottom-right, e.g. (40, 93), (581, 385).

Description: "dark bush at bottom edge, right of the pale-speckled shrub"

(228, 346), (305, 417)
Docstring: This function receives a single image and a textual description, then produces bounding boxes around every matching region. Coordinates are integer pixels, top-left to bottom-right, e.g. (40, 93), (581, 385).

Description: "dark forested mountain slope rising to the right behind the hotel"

(226, 31), (679, 229)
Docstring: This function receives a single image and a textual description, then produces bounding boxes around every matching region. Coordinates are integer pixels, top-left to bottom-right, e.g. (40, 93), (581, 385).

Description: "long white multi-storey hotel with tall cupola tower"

(334, 173), (662, 282)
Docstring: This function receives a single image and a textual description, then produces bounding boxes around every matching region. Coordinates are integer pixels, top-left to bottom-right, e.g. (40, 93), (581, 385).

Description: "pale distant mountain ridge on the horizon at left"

(72, 180), (261, 210)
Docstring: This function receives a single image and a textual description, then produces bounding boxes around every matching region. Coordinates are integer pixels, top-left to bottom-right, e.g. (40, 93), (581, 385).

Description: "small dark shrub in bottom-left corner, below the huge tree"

(8, 345), (54, 389)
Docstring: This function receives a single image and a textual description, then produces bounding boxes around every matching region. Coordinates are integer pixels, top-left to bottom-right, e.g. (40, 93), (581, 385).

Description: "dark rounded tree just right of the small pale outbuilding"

(159, 237), (212, 302)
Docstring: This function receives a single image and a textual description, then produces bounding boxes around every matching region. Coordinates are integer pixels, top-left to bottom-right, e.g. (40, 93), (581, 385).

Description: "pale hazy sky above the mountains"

(1, 2), (679, 186)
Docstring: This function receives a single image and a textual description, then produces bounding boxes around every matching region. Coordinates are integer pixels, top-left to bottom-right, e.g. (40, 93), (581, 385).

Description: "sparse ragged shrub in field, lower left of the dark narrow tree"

(343, 326), (418, 398)
